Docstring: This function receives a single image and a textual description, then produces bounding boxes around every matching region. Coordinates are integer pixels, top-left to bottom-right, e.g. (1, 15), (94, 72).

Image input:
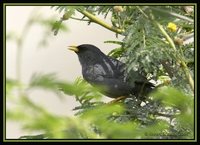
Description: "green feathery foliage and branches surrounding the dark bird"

(6, 6), (195, 139)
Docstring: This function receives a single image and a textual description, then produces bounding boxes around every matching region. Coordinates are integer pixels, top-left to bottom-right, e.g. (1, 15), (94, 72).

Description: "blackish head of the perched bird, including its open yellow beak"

(69, 44), (105, 64)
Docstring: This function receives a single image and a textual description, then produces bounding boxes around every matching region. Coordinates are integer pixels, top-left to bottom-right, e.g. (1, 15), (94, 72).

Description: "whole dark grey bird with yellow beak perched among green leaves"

(69, 44), (154, 100)
